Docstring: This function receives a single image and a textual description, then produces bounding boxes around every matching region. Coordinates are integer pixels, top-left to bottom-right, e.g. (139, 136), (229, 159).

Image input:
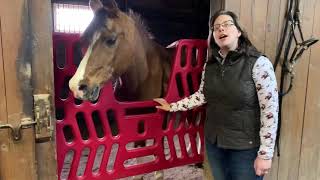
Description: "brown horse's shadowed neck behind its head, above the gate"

(120, 39), (170, 100)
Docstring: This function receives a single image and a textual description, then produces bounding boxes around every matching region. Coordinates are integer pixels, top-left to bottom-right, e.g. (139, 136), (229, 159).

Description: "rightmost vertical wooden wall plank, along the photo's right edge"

(299, 1), (320, 180)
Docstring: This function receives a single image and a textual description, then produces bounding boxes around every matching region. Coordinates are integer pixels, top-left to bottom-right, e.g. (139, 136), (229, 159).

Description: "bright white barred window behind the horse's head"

(53, 3), (93, 33)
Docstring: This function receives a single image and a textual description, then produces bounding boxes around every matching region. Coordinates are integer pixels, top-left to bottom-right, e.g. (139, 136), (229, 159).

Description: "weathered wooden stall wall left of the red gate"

(0, 0), (57, 180)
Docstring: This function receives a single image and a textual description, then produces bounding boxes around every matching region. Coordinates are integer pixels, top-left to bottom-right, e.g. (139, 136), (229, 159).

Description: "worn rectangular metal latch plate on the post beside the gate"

(33, 94), (53, 142)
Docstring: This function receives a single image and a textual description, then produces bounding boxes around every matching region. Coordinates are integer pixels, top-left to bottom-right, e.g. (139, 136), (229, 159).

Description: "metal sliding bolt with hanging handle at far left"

(0, 118), (37, 141)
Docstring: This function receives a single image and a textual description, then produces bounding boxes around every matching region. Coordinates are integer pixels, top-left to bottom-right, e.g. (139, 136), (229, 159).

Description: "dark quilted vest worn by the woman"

(204, 51), (261, 149)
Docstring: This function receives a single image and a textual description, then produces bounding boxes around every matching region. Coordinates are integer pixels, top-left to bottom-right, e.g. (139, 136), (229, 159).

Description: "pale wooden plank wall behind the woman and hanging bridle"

(211, 0), (320, 180)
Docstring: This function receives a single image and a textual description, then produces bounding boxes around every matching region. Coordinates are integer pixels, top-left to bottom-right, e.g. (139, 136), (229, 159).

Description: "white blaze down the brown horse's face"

(69, 32), (101, 98)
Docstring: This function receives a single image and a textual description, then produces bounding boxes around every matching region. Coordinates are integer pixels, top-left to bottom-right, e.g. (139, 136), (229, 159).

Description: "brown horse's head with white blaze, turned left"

(69, 0), (148, 101)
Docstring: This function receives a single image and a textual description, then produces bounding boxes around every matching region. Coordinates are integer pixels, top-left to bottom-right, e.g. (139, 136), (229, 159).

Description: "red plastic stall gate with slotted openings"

(53, 34), (207, 180)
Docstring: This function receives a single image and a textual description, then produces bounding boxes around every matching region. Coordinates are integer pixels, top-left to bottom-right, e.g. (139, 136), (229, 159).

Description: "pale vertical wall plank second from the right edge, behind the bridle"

(278, 0), (315, 180)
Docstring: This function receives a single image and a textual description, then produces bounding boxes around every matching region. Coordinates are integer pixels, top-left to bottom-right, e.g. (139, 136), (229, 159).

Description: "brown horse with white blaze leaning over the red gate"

(69, 0), (172, 101)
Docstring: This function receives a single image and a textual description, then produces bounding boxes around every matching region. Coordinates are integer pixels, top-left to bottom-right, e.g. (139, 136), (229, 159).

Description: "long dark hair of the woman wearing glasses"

(209, 10), (259, 55)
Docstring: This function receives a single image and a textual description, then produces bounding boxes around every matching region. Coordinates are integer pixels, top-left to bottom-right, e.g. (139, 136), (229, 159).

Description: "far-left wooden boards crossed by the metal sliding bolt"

(0, 0), (37, 180)
